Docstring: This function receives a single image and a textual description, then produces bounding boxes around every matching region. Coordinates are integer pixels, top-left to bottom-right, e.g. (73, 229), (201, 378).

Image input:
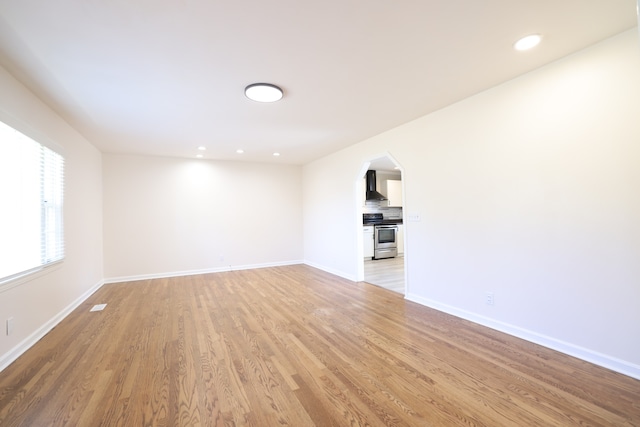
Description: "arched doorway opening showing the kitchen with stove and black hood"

(358, 154), (406, 295)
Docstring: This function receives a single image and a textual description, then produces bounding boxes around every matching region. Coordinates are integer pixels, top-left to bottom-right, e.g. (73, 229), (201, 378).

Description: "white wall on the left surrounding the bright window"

(0, 68), (103, 370)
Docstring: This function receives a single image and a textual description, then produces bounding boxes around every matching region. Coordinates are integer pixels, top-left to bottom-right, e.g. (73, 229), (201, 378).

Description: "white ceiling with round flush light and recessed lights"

(0, 0), (637, 164)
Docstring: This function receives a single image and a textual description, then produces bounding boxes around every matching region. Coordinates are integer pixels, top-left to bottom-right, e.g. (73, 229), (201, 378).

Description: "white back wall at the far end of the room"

(103, 154), (303, 281)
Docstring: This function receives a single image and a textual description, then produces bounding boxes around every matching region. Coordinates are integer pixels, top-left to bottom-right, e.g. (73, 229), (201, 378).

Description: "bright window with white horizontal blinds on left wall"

(0, 118), (64, 285)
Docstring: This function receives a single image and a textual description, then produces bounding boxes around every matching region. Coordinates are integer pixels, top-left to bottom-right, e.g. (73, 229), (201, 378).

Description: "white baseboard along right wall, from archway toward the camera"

(405, 293), (640, 380)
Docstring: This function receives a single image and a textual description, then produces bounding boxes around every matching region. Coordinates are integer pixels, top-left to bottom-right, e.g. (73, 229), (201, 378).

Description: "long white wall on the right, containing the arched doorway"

(303, 30), (640, 378)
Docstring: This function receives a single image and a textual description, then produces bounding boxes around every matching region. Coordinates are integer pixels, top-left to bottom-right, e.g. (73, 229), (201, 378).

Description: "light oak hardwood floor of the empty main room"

(0, 265), (640, 427)
